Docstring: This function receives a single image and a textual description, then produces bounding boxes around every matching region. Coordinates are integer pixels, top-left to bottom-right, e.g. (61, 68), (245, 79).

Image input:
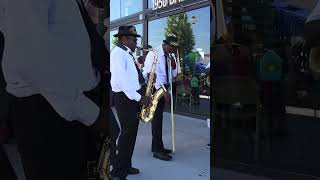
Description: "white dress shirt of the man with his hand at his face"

(143, 45), (177, 89)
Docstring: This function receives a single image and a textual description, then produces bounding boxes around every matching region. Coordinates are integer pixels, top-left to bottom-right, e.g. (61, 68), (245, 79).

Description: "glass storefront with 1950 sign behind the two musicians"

(109, 0), (212, 118)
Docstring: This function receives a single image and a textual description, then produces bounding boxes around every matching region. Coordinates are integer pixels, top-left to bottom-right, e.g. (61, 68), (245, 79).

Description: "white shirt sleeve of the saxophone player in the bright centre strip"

(110, 51), (141, 101)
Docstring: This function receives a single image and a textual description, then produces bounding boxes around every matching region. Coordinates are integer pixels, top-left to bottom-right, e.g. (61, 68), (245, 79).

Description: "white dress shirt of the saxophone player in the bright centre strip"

(110, 46), (141, 101)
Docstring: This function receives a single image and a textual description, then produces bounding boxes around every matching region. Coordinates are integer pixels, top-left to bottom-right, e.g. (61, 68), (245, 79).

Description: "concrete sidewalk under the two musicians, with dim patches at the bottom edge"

(6, 113), (270, 180)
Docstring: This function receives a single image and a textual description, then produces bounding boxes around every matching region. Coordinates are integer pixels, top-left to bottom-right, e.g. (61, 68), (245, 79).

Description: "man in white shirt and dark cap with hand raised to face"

(143, 35), (178, 161)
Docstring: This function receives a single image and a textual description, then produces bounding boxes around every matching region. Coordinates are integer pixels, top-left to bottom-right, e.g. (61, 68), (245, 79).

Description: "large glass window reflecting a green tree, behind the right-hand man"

(148, 7), (210, 116)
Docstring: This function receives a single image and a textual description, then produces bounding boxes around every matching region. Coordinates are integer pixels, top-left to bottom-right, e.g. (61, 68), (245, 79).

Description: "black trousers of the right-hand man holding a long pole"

(151, 97), (166, 152)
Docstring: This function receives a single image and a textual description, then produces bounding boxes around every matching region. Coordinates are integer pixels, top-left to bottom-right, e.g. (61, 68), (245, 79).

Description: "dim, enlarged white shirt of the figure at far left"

(0, 0), (99, 126)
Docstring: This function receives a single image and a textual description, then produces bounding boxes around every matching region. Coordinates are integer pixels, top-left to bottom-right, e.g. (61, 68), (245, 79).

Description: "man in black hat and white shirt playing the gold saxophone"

(110, 26), (151, 180)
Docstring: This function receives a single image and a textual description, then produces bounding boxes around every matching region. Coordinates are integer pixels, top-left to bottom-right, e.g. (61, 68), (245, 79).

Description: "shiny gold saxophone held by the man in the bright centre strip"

(139, 49), (167, 123)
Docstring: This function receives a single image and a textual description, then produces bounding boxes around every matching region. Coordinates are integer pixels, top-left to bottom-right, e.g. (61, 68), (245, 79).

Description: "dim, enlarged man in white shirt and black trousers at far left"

(0, 0), (107, 180)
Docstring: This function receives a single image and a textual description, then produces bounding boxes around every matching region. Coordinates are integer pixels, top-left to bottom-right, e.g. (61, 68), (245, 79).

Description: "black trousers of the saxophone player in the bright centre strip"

(112, 92), (139, 178)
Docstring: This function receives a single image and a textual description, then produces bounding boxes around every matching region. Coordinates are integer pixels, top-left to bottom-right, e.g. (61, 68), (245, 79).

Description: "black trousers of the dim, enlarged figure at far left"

(13, 95), (95, 180)
